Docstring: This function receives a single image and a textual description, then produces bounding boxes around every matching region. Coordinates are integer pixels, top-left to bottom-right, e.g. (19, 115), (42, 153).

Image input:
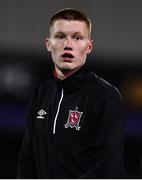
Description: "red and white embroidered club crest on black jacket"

(65, 110), (83, 130)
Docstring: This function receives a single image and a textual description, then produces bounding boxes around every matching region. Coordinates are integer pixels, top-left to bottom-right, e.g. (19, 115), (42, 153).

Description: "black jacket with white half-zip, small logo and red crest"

(17, 66), (124, 179)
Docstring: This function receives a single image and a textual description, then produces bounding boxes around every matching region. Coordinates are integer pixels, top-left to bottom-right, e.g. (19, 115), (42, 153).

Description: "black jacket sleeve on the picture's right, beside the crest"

(79, 88), (125, 179)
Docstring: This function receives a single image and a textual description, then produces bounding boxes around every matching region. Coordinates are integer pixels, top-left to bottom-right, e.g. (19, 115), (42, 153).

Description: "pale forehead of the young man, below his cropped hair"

(51, 19), (89, 34)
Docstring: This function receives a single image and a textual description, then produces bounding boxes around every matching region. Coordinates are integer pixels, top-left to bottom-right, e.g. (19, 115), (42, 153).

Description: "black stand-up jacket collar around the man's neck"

(54, 64), (90, 93)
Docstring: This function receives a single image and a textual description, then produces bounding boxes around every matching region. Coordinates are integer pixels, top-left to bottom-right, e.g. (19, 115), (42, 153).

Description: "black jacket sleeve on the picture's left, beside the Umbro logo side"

(17, 88), (37, 179)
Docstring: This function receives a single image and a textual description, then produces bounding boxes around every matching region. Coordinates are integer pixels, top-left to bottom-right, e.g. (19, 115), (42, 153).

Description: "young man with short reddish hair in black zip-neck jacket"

(18, 9), (124, 179)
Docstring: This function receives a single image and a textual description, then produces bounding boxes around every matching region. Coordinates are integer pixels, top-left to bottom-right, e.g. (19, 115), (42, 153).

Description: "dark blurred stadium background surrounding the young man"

(0, 0), (142, 179)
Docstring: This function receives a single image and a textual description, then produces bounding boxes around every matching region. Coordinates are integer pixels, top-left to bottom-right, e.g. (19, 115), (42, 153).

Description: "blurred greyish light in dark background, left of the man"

(0, 64), (33, 100)
